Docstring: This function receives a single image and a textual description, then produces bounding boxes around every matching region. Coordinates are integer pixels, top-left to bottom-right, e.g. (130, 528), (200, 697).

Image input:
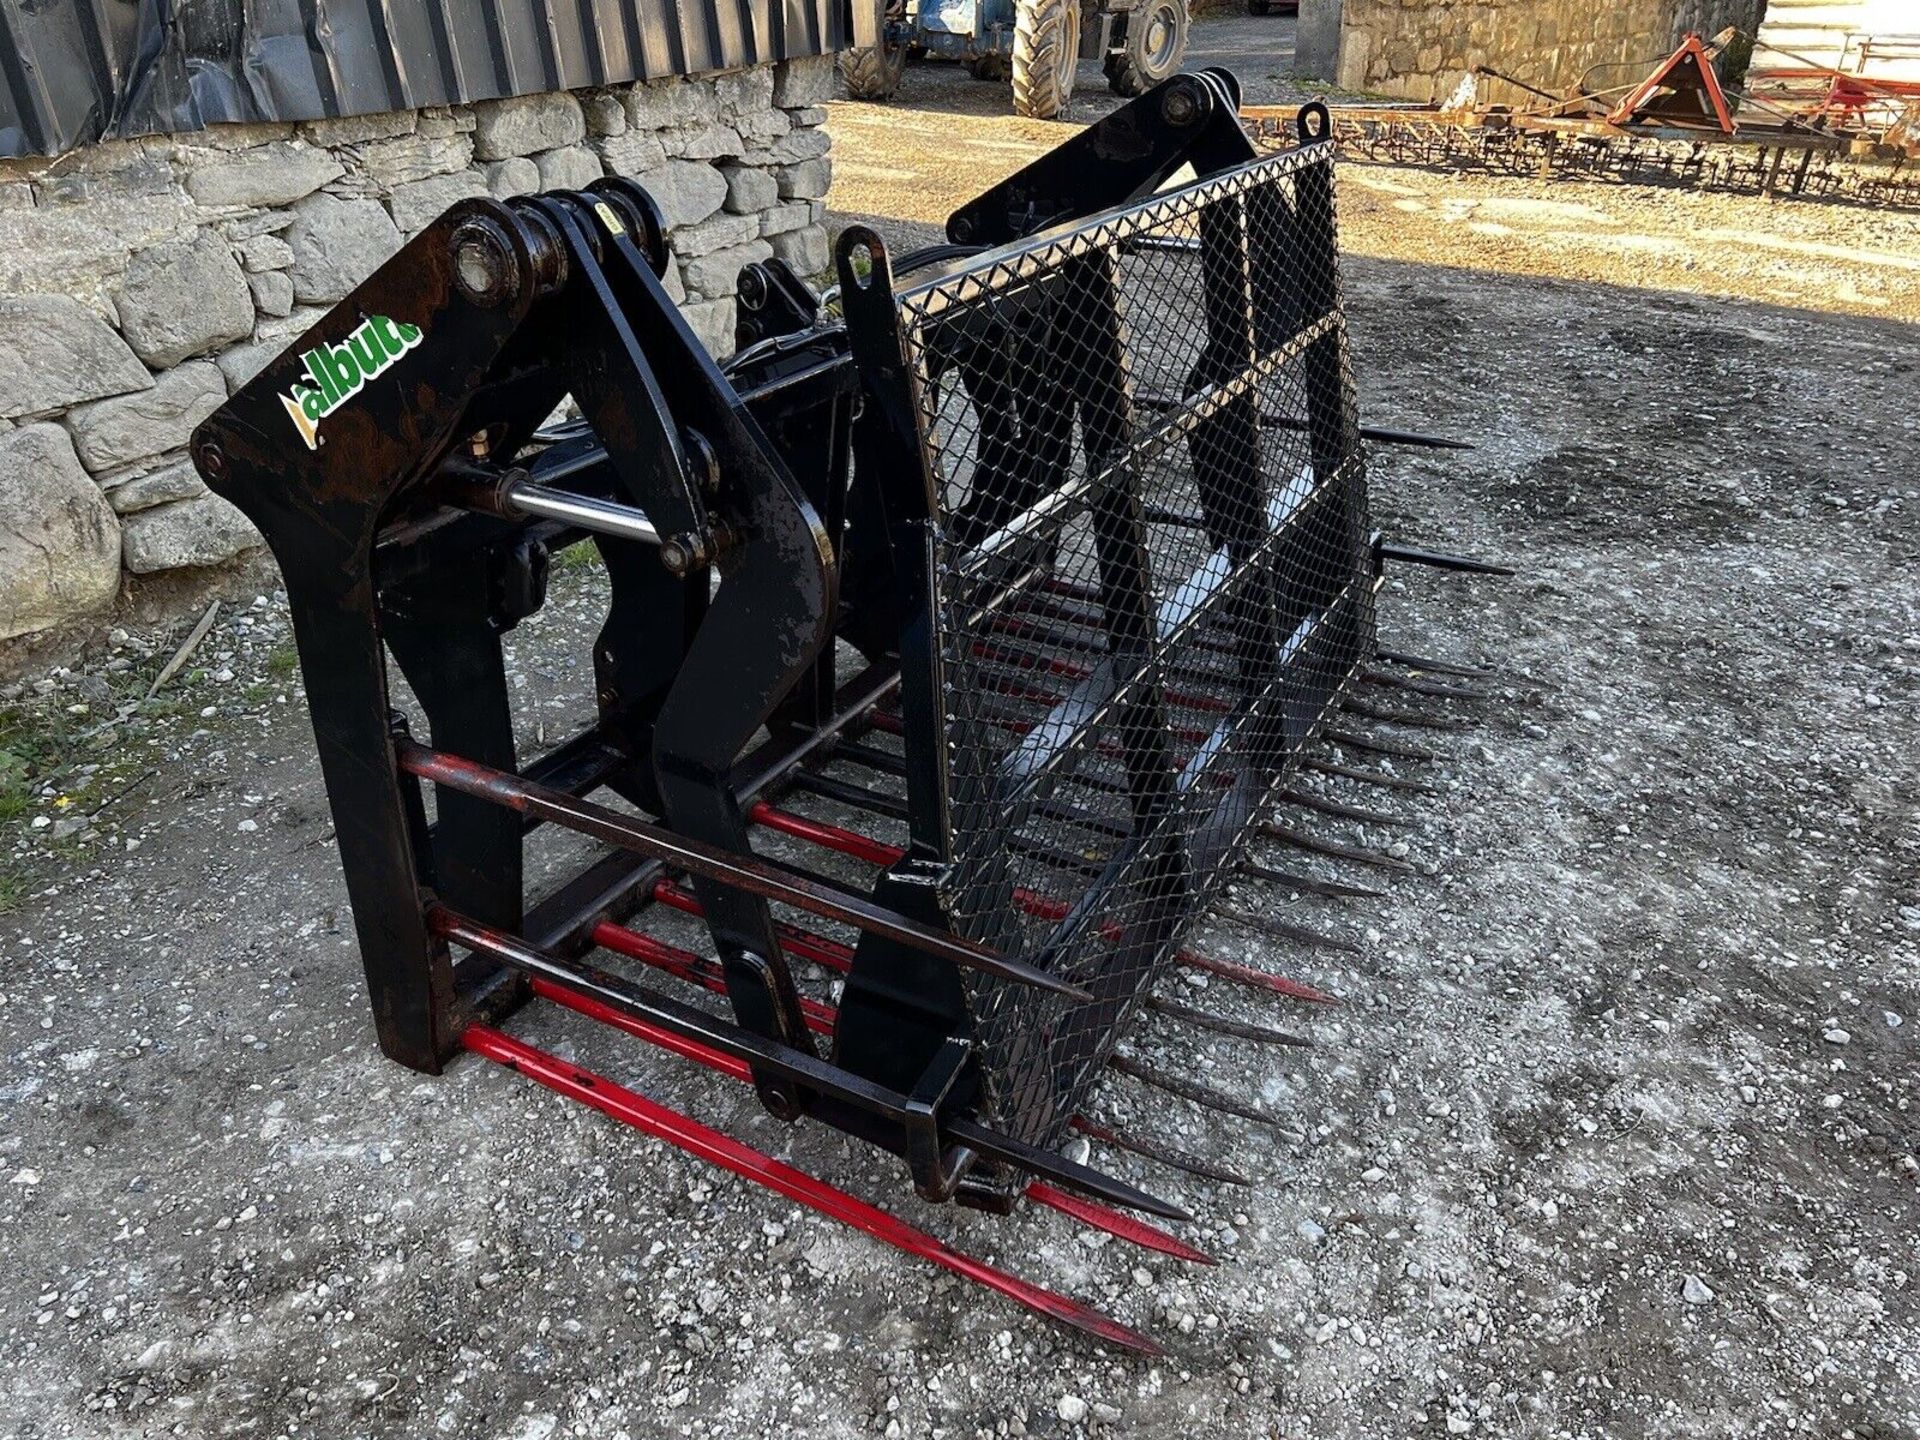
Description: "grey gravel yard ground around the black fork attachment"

(0, 19), (1920, 1440)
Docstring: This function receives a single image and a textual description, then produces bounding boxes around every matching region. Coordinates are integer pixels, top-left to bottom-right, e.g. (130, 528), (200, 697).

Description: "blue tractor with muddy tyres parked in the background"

(841, 0), (1188, 119)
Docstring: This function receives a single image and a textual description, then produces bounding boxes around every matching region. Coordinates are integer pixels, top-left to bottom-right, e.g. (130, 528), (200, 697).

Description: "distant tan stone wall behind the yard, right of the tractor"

(1296, 0), (1766, 104)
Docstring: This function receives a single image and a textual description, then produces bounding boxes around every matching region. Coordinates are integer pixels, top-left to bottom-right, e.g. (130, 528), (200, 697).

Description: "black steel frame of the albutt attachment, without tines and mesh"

(192, 73), (1373, 1213)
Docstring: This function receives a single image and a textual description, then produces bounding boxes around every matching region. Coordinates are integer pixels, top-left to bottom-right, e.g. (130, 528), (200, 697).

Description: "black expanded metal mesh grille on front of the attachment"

(899, 146), (1373, 1140)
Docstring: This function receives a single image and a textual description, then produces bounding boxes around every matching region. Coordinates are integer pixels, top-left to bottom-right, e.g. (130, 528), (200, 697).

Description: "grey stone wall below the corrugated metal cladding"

(0, 58), (833, 641)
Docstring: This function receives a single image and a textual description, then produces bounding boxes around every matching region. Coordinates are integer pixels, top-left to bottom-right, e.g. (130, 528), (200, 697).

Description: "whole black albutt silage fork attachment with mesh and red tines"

(194, 71), (1497, 1350)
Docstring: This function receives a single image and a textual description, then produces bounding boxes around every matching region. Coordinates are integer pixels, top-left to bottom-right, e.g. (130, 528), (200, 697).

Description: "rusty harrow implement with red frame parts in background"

(1244, 29), (1920, 205)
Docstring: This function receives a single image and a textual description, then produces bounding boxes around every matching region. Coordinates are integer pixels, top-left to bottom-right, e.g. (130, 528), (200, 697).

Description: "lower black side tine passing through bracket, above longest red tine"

(439, 904), (1192, 1221)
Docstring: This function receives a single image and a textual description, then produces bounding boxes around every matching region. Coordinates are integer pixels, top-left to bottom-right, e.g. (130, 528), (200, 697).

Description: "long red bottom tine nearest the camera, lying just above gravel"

(461, 1025), (1165, 1356)
